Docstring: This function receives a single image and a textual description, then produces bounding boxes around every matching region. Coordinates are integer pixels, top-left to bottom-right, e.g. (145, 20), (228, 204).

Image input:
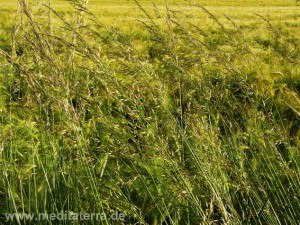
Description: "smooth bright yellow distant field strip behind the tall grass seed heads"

(0, 0), (300, 32)
